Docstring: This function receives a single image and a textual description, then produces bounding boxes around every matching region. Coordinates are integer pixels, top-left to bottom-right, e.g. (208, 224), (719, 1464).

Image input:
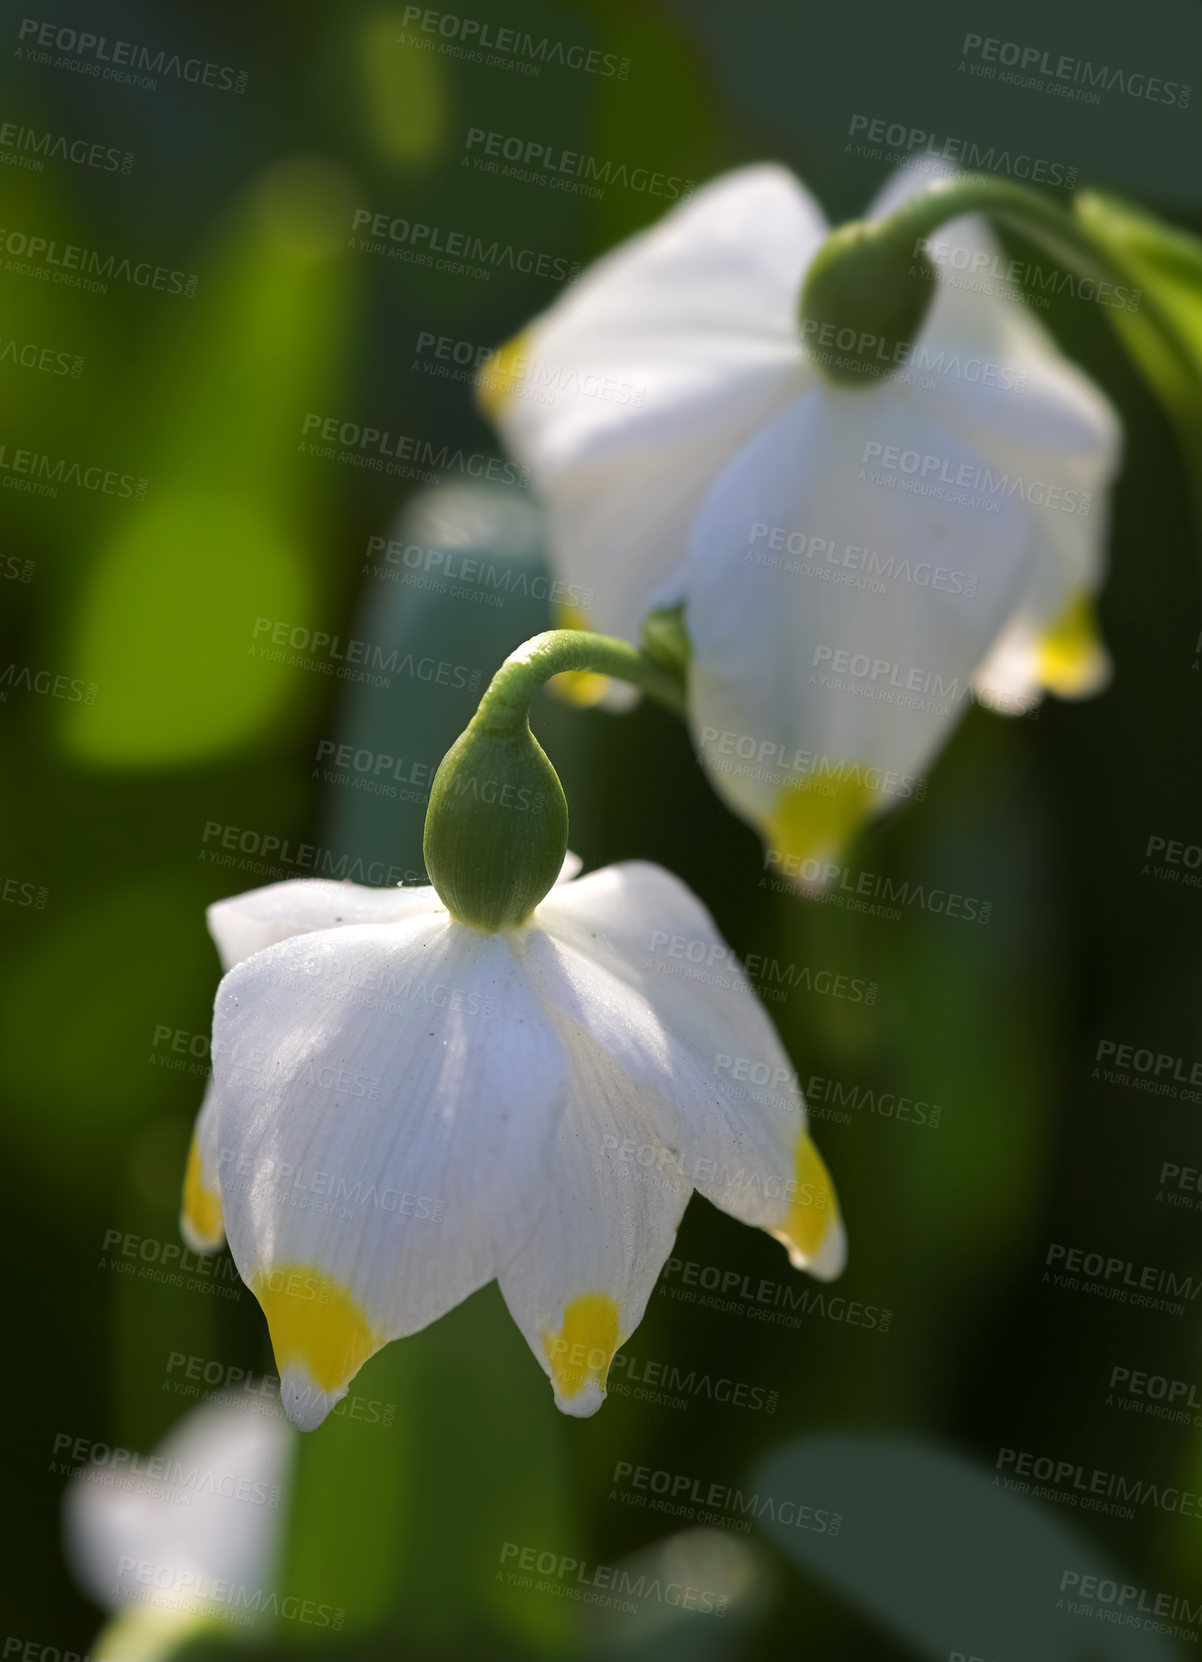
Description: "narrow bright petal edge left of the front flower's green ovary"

(208, 878), (446, 969)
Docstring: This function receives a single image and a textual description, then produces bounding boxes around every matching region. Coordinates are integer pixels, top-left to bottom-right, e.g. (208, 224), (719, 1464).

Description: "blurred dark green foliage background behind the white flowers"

(0, 0), (1202, 1662)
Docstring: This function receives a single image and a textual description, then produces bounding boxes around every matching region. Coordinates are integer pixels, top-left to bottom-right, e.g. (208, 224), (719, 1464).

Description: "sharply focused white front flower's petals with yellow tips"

(186, 856), (845, 1429)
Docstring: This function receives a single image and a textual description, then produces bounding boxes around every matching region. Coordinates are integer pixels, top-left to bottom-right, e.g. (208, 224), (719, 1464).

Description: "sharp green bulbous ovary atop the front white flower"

(424, 710), (567, 931)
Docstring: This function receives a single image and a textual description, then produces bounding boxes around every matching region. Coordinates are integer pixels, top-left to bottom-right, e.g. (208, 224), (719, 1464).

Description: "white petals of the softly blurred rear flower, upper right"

(480, 166), (1119, 868)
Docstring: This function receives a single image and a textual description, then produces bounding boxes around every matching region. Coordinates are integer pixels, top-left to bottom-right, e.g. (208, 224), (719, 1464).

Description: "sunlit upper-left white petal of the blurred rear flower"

(499, 165), (826, 485)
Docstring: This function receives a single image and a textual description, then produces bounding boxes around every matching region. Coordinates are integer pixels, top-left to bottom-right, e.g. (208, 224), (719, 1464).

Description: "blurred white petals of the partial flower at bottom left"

(63, 1403), (296, 1609)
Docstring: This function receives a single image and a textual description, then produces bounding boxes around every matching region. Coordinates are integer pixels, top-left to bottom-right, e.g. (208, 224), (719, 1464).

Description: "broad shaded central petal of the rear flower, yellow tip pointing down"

(687, 382), (1032, 859)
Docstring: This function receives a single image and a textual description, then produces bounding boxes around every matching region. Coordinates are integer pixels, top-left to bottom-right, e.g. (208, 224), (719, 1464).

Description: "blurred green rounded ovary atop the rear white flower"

(801, 219), (936, 387)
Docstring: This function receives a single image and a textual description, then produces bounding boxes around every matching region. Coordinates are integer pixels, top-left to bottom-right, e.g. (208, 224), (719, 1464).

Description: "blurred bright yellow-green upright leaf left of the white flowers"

(63, 158), (352, 768)
